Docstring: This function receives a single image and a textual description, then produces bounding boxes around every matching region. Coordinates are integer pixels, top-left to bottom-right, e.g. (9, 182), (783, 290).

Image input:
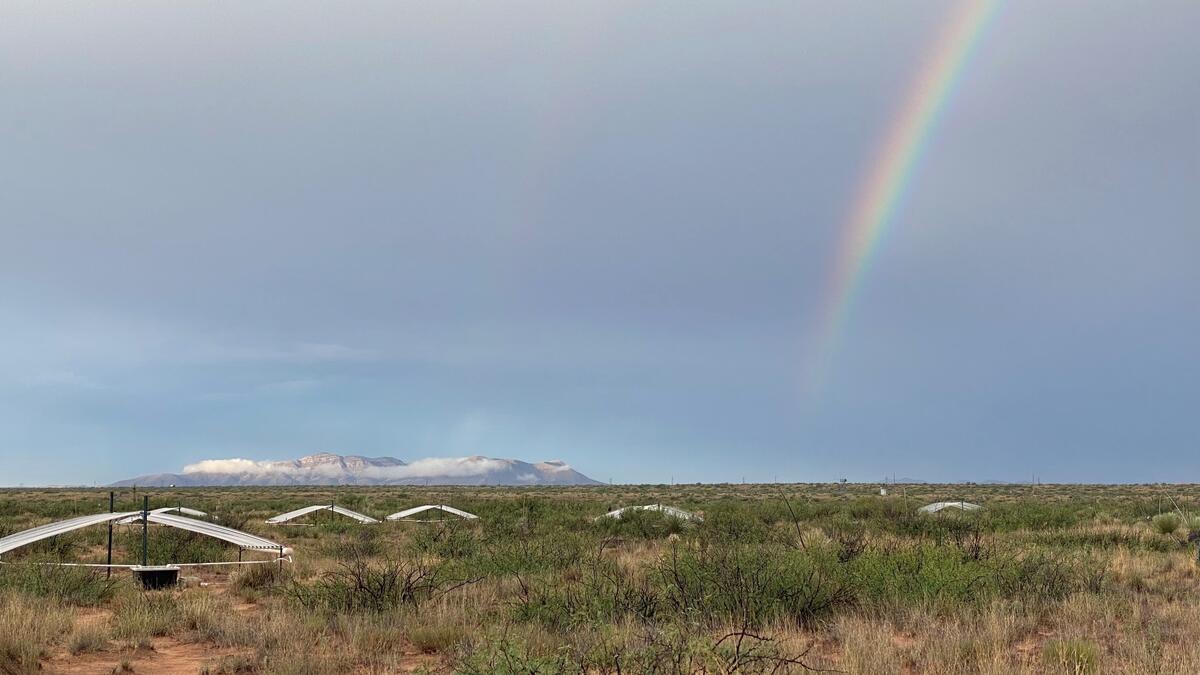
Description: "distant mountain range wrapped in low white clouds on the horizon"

(112, 453), (600, 488)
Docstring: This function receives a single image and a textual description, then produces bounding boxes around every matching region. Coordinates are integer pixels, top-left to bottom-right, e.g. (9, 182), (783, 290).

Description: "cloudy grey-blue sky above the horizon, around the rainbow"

(0, 0), (1200, 485)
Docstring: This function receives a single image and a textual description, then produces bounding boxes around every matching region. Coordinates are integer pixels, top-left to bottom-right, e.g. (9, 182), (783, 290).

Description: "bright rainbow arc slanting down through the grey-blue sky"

(805, 0), (1000, 394)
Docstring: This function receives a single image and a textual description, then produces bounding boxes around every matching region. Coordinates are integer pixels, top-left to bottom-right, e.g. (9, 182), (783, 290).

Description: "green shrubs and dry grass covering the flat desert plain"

(0, 485), (1200, 675)
